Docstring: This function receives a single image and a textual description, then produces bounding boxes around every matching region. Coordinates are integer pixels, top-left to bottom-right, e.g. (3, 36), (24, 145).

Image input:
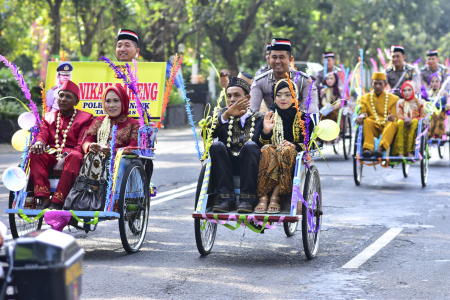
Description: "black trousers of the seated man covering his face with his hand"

(210, 141), (261, 204)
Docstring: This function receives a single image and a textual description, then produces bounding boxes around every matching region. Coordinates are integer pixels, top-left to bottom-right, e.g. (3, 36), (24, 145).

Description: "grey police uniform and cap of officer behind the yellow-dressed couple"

(386, 45), (421, 98)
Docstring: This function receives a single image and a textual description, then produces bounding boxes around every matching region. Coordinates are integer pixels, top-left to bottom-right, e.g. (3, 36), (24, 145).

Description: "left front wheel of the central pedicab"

(194, 165), (217, 255)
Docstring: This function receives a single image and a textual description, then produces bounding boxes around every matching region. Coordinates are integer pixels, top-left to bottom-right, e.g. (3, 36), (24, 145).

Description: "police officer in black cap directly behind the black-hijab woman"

(250, 38), (319, 113)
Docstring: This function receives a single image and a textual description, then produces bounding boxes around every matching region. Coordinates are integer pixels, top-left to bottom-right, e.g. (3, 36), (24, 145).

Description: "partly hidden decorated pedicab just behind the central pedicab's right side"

(320, 59), (354, 160)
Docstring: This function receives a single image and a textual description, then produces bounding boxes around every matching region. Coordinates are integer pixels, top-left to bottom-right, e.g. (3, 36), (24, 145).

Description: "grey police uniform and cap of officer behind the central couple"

(250, 38), (319, 113)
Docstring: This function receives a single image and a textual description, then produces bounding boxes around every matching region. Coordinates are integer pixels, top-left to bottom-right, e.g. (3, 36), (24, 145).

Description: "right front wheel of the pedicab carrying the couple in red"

(119, 162), (150, 254)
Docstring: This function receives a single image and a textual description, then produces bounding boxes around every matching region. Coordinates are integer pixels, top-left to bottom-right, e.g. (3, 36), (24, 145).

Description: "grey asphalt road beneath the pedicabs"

(0, 129), (450, 299)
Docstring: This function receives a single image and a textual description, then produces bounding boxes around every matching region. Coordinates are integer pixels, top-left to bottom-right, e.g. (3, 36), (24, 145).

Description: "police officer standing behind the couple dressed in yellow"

(386, 45), (421, 98)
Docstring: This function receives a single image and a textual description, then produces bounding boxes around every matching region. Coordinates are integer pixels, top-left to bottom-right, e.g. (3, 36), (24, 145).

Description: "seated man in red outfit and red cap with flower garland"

(30, 80), (94, 209)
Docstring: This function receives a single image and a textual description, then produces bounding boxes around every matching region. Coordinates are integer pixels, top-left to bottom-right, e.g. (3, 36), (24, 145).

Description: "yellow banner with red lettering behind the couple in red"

(45, 61), (166, 122)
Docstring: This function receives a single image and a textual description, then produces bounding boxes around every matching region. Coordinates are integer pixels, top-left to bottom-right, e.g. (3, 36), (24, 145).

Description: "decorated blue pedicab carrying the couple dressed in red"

(1, 57), (174, 254)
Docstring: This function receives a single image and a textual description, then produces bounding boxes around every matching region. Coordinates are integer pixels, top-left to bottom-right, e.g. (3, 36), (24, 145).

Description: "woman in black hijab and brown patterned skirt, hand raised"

(255, 79), (313, 214)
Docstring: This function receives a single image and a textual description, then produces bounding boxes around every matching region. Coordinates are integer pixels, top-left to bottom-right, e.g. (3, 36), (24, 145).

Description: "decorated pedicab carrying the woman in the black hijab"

(184, 68), (339, 259)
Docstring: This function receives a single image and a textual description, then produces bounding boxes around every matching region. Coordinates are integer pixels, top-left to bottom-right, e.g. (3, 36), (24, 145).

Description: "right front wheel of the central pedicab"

(302, 166), (323, 259)
